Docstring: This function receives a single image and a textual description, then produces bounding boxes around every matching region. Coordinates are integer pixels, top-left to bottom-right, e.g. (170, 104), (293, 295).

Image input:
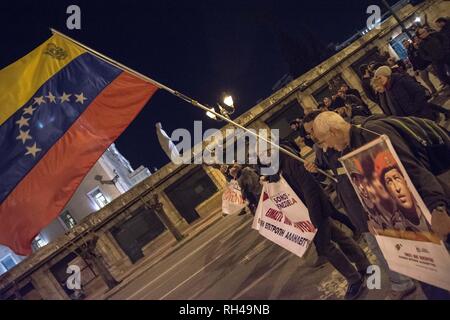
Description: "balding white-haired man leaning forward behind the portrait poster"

(313, 111), (450, 299)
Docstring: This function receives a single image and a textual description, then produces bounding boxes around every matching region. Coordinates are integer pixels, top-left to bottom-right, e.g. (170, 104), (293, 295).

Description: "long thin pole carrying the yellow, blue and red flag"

(50, 28), (337, 182)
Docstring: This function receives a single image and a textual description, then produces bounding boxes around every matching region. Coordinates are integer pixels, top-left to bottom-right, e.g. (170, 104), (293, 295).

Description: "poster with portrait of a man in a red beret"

(340, 135), (450, 290)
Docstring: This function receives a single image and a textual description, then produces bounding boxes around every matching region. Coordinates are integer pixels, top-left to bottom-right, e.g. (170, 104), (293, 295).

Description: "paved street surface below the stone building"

(105, 215), (423, 300)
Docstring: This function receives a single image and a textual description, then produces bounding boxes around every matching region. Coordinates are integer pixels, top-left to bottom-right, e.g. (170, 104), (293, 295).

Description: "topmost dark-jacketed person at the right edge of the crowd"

(416, 27), (450, 85)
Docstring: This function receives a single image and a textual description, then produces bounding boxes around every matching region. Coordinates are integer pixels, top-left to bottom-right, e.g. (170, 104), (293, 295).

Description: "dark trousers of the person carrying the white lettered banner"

(314, 218), (370, 284)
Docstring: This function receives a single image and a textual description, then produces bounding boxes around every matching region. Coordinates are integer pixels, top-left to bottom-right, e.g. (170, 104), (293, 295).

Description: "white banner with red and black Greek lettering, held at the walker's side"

(252, 178), (317, 257)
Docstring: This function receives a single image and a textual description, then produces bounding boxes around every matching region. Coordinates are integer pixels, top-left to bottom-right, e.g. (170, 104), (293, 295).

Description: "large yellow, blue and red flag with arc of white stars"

(0, 34), (157, 255)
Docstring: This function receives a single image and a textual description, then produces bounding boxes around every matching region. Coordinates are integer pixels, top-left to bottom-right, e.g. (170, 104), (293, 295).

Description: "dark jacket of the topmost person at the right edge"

(419, 32), (450, 63)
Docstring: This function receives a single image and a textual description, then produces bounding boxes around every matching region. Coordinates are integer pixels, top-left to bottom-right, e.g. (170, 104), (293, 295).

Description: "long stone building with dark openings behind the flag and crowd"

(0, 0), (450, 299)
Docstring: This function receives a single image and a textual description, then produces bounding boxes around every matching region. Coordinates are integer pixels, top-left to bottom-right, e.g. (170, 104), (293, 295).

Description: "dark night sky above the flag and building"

(0, 0), (396, 169)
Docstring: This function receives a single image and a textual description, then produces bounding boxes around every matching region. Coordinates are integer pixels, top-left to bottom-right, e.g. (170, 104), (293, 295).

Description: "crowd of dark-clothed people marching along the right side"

(221, 18), (450, 299)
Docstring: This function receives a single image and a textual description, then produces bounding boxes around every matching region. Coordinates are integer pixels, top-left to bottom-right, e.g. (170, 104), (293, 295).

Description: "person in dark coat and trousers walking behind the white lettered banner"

(272, 144), (370, 299)
